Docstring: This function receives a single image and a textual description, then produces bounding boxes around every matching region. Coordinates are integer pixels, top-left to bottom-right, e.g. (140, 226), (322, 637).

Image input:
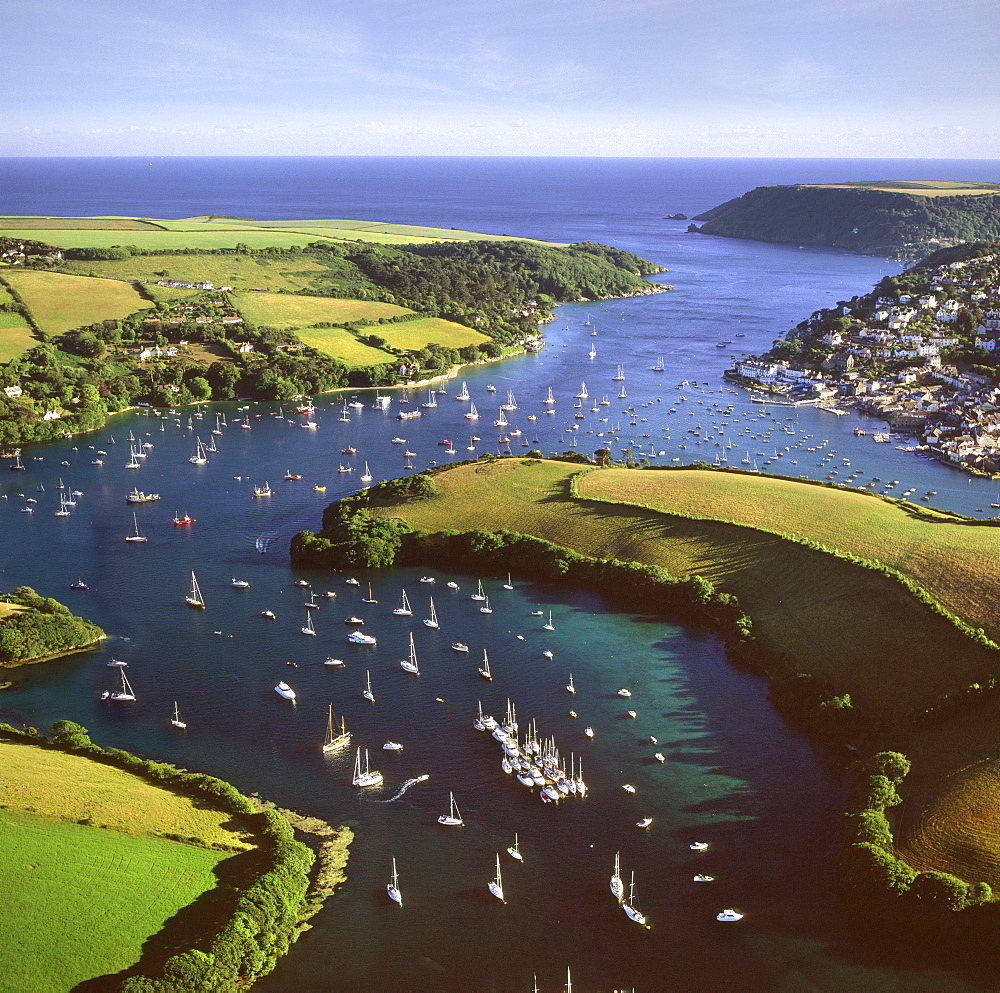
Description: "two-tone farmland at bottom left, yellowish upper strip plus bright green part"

(0, 741), (250, 993)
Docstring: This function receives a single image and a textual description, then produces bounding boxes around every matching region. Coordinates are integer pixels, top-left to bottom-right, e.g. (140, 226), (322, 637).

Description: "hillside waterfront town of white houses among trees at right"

(720, 246), (1000, 479)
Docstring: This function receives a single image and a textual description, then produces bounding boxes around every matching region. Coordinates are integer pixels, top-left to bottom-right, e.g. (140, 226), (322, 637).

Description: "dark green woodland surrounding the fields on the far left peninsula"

(0, 239), (661, 446)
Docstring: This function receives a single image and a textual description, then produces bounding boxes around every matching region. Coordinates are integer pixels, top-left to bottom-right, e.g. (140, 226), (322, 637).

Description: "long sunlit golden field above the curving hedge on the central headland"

(580, 469), (1000, 639)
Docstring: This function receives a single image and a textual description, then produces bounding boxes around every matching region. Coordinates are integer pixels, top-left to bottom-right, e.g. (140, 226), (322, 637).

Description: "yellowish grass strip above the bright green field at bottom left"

(0, 741), (251, 848)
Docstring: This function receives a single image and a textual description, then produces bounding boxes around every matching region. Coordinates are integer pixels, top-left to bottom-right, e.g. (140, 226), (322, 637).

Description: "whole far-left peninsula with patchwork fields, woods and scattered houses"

(0, 216), (668, 448)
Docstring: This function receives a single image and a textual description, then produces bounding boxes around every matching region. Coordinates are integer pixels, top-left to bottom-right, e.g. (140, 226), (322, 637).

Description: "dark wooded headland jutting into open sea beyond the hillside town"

(692, 183), (1000, 257)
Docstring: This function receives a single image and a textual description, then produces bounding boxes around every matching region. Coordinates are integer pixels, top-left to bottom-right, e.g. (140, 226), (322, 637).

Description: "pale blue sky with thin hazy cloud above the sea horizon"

(0, 0), (1000, 158)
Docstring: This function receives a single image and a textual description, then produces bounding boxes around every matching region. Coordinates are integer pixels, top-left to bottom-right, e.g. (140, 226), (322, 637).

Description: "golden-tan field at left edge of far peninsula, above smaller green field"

(4, 269), (153, 335)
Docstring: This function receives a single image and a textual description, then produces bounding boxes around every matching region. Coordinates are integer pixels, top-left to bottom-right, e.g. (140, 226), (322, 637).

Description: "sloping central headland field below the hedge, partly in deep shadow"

(374, 459), (1000, 722)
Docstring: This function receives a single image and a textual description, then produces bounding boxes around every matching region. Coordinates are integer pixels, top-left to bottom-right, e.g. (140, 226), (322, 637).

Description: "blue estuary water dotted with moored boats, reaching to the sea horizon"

(0, 159), (1000, 993)
